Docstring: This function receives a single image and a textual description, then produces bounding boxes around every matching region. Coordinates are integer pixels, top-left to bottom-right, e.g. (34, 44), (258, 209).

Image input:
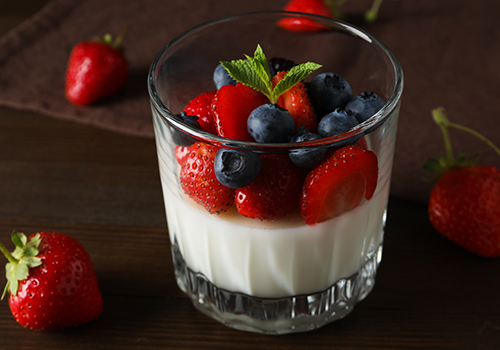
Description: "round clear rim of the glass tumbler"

(147, 10), (404, 150)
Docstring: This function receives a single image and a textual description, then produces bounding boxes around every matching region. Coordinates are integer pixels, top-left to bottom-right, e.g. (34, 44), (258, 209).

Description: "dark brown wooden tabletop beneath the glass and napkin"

(0, 0), (500, 350)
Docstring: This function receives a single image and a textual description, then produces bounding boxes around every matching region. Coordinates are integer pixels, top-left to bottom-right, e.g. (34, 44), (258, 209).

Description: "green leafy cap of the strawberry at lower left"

(0, 231), (42, 300)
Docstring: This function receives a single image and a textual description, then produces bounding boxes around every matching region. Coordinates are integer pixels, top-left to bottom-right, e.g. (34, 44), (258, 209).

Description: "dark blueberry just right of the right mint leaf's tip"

(308, 73), (352, 118)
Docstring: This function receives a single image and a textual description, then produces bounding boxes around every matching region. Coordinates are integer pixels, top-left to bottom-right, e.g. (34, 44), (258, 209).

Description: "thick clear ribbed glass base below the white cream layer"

(172, 242), (382, 334)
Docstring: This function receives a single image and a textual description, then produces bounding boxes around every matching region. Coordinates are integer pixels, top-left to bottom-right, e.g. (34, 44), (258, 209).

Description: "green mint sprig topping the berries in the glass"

(221, 45), (321, 104)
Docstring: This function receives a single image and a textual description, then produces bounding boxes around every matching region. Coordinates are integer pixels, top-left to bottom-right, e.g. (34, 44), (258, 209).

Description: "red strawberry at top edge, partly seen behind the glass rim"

(278, 0), (335, 33)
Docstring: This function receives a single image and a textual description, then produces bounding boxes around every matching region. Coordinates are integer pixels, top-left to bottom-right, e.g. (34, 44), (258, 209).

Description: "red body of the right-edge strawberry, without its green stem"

(429, 166), (500, 257)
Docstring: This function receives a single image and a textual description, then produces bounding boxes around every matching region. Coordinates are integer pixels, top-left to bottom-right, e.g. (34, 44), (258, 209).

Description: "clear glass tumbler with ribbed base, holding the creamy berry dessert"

(148, 11), (403, 334)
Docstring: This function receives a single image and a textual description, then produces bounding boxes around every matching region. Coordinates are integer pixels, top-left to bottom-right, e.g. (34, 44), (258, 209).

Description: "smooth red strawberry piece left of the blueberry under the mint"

(211, 83), (267, 141)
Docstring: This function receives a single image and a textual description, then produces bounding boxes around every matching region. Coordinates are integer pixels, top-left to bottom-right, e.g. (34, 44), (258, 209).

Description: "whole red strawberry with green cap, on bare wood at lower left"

(0, 232), (103, 330)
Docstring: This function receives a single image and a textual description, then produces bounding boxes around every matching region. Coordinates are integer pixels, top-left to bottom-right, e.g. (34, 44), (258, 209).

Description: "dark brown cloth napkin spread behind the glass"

(0, 0), (500, 202)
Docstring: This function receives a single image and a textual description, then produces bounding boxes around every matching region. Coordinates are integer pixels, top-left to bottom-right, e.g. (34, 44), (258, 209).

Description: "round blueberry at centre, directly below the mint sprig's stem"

(247, 103), (295, 143)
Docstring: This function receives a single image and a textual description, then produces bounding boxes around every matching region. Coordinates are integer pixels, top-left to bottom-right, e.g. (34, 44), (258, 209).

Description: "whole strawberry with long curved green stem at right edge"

(424, 108), (500, 257)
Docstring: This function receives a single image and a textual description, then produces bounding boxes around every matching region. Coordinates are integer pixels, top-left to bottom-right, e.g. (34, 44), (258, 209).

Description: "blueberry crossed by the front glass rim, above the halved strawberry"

(289, 127), (326, 168)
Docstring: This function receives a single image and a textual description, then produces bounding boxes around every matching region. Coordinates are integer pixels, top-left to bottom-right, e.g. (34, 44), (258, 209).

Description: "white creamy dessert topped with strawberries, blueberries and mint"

(155, 46), (392, 298)
